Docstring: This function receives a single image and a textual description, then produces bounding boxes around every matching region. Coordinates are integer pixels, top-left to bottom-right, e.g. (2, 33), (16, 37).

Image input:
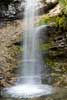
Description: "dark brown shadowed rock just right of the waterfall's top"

(39, 0), (59, 15)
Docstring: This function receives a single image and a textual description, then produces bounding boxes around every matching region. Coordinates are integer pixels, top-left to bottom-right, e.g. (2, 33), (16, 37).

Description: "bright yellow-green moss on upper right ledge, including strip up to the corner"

(38, 0), (67, 29)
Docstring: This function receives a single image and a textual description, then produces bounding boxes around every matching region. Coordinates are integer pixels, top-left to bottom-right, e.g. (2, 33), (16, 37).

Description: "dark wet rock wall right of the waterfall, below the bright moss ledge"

(40, 23), (67, 87)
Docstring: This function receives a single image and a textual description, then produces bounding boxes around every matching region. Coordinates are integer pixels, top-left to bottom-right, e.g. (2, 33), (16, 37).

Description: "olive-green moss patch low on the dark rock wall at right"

(45, 58), (67, 73)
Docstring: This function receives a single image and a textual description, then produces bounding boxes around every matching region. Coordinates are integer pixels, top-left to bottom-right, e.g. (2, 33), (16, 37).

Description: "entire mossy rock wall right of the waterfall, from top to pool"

(38, 0), (67, 87)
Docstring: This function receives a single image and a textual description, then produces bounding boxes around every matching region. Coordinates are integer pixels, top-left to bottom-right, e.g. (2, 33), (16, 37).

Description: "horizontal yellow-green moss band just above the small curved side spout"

(38, 14), (67, 30)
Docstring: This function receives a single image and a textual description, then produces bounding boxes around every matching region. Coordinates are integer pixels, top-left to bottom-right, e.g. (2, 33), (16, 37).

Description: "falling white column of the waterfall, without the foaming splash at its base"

(22, 0), (41, 84)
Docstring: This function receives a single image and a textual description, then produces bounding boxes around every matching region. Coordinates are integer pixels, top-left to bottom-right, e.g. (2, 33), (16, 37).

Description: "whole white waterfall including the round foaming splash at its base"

(3, 0), (53, 98)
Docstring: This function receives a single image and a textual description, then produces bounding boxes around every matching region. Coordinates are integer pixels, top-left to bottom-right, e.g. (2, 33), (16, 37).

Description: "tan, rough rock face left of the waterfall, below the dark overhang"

(0, 20), (23, 87)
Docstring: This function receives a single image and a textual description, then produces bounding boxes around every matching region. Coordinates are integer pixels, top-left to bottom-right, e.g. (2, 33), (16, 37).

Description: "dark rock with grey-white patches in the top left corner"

(0, 0), (24, 20)
